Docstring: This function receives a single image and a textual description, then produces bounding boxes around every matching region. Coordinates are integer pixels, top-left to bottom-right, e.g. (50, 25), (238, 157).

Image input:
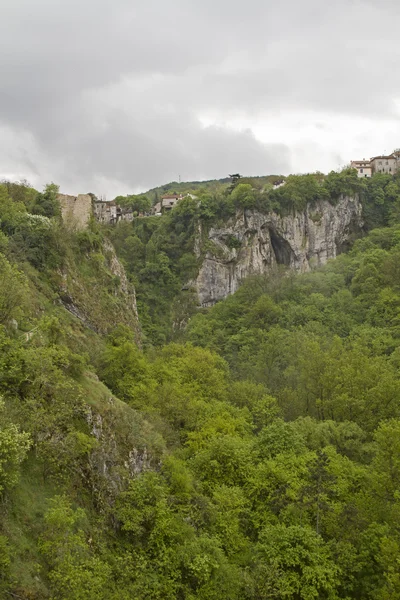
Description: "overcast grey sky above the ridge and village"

(0, 0), (400, 199)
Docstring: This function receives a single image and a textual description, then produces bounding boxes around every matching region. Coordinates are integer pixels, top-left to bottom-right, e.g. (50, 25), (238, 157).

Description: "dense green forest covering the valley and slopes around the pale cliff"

(0, 170), (400, 600)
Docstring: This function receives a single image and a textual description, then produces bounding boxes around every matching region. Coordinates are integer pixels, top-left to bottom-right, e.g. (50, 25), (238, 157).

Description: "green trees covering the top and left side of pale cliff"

(107, 169), (400, 345)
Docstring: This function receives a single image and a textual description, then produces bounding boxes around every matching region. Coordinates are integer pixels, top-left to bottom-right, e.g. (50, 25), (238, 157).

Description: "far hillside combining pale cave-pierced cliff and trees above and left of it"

(107, 169), (400, 345)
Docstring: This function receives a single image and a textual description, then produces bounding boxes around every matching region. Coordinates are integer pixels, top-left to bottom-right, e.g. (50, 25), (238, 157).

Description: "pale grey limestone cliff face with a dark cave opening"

(194, 196), (363, 307)
